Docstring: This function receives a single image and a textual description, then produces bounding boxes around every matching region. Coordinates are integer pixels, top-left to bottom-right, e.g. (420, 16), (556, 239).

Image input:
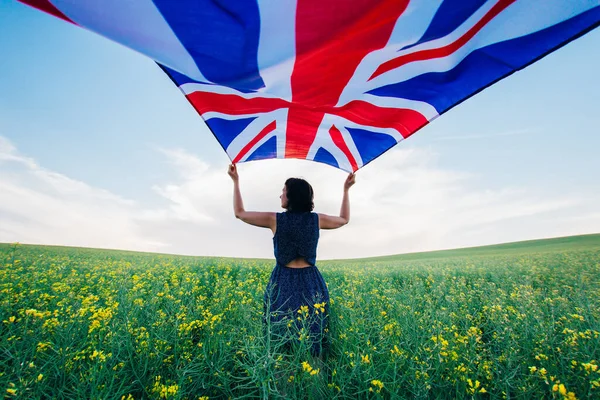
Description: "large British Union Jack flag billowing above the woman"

(22, 0), (600, 171)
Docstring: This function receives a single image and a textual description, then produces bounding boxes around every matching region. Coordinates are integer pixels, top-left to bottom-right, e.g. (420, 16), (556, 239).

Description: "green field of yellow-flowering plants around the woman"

(0, 235), (600, 399)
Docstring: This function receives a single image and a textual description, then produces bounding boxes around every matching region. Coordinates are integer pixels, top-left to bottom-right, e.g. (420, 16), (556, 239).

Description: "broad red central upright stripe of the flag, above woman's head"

(285, 0), (408, 158)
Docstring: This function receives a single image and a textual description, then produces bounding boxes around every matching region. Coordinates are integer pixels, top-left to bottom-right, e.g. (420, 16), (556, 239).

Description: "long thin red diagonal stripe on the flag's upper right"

(369, 0), (516, 80)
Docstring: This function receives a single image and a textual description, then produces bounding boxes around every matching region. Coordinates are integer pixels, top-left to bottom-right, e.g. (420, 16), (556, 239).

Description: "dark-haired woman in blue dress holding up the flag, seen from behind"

(228, 164), (355, 356)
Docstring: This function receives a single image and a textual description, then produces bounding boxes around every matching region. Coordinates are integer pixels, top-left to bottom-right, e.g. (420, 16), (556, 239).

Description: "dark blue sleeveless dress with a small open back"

(263, 211), (330, 356)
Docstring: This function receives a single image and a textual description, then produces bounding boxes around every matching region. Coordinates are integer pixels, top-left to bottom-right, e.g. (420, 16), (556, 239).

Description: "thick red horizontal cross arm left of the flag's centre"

(186, 91), (290, 115)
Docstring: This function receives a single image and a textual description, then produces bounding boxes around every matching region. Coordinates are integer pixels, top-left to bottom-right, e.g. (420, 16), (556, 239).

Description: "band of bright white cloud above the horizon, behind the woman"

(0, 137), (600, 259)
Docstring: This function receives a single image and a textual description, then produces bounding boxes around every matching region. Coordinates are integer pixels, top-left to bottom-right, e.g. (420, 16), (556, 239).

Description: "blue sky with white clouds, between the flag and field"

(0, 0), (600, 259)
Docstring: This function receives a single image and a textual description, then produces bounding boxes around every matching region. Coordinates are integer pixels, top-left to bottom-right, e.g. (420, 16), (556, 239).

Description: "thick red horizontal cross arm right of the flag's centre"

(331, 100), (427, 139)
